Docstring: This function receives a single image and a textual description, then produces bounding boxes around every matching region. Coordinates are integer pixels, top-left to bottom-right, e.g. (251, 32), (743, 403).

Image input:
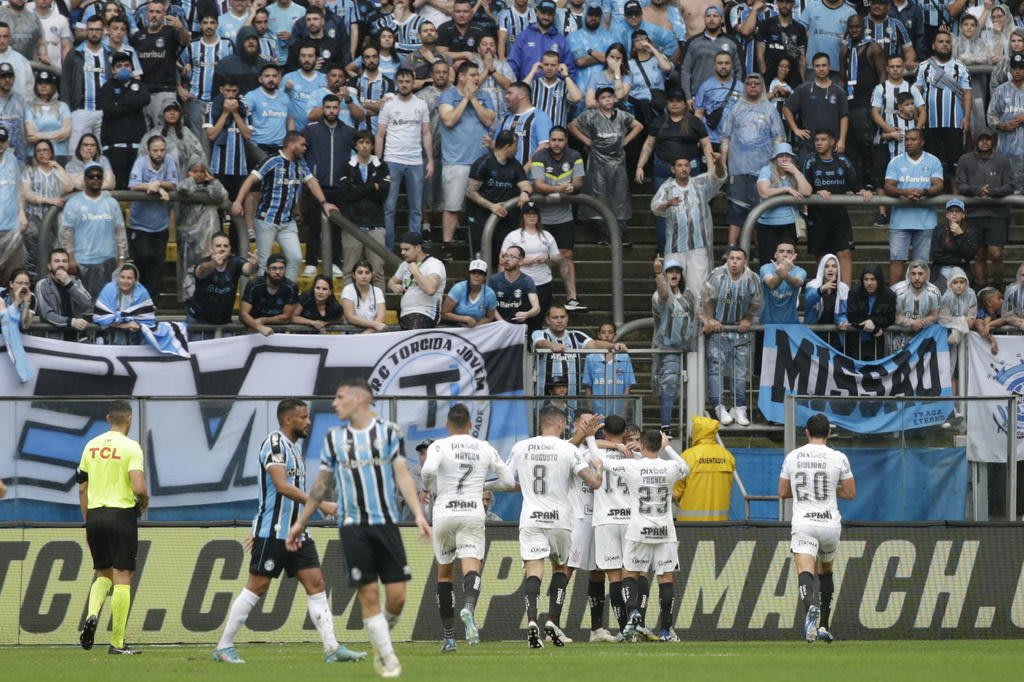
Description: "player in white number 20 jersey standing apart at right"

(778, 414), (857, 643)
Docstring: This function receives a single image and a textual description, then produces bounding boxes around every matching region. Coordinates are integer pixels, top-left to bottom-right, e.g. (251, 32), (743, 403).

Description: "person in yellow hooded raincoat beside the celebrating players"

(672, 416), (736, 522)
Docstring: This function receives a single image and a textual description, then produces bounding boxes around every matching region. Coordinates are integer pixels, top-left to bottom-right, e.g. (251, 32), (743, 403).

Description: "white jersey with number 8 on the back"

(509, 436), (590, 530)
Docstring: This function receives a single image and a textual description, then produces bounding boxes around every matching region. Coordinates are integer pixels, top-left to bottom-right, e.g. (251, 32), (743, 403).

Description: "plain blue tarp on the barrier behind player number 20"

(729, 447), (968, 521)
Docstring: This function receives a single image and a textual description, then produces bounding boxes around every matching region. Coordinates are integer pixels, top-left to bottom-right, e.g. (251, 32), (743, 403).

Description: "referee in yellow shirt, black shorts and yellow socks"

(77, 400), (150, 655)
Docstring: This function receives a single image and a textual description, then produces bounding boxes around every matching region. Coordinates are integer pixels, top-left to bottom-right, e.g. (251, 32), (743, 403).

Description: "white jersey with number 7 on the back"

(421, 434), (512, 519)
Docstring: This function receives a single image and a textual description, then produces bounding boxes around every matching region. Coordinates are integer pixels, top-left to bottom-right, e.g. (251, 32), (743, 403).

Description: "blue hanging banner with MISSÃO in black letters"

(758, 325), (953, 433)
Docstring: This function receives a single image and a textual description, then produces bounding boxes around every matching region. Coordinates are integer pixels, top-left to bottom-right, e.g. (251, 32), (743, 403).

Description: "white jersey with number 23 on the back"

(604, 456), (690, 544)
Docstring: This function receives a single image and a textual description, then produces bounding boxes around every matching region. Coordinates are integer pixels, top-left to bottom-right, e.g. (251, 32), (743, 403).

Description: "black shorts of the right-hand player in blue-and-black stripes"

(339, 524), (413, 587)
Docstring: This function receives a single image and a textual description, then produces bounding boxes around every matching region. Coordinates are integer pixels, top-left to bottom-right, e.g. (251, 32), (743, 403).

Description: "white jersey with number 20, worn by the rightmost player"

(779, 443), (853, 526)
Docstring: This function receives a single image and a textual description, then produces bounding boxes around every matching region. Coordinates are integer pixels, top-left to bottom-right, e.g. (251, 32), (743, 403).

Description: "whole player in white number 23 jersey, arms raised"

(592, 430), (690, 642)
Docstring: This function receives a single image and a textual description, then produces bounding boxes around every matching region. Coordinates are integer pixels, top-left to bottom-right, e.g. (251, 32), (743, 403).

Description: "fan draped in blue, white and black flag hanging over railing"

(92, 263), (188, 357)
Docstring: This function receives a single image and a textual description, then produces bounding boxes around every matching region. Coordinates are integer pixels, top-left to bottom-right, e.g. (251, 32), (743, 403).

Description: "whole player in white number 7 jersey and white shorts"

(421, 402), (515, 653)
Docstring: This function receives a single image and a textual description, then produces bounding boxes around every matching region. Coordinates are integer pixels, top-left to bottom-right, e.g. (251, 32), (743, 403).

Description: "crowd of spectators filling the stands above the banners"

(0, 0), (1024, 424)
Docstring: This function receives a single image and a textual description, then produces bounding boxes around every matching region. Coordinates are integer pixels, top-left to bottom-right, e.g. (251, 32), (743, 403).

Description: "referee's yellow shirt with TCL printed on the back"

(78, 431), (142, 509)
